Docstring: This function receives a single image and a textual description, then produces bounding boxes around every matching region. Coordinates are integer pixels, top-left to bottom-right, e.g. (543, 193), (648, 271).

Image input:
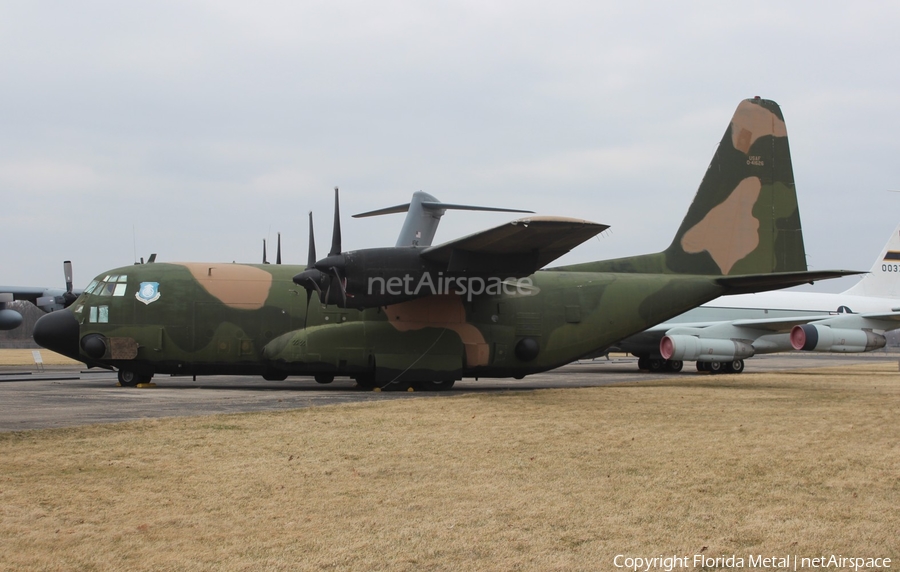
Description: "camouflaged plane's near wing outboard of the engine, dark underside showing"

(421, 217), (609, 277)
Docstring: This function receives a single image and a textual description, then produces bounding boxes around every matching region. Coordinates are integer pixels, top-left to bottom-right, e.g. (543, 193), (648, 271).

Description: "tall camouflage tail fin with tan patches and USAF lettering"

(566, 98), (806, 276)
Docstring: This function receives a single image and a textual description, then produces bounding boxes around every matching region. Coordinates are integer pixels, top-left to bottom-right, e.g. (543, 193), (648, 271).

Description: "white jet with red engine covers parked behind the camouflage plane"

(611, 226), (900, 373)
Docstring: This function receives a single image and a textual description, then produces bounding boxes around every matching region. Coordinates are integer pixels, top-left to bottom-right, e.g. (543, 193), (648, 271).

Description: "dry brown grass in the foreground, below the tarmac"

(0, 363), (900, 571)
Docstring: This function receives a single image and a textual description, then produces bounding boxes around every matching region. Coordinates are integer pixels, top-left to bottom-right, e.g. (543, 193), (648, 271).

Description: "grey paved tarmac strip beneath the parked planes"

(0, 353), (898, 431)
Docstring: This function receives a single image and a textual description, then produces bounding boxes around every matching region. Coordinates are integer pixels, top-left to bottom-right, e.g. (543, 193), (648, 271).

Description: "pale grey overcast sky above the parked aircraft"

(0, 0), (900, 287)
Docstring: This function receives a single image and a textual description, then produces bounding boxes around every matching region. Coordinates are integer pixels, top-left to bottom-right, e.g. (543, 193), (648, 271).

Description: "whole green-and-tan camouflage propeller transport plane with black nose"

(34, 98), (848, 390)
